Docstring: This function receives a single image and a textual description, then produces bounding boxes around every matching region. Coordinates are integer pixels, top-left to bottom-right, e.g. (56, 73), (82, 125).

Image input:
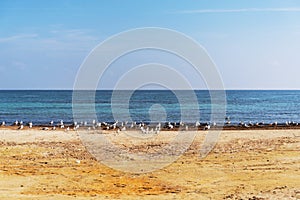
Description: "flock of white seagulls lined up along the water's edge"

(1, 117), (299, 134)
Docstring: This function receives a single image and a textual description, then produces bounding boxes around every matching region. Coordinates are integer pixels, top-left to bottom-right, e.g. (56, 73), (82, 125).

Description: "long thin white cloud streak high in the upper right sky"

(176, 8), (300, 14)
